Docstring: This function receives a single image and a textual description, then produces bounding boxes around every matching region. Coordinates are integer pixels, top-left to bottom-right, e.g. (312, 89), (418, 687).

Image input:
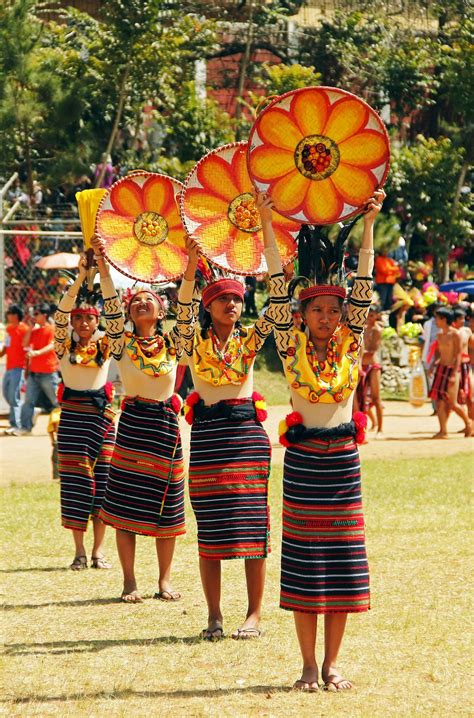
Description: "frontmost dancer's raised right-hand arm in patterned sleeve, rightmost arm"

(347, 189), (386, 336)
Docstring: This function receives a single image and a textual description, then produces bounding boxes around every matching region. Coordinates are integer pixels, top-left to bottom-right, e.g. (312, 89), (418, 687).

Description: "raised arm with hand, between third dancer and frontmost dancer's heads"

(255, 192), (293, 357)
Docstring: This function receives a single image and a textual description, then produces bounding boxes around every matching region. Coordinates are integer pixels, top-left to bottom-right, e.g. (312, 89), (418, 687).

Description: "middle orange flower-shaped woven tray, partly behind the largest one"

(181, 142), (299, 274)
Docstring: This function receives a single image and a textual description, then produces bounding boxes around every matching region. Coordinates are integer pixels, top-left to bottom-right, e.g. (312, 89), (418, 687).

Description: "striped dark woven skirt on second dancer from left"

(100, 398), (185, 538)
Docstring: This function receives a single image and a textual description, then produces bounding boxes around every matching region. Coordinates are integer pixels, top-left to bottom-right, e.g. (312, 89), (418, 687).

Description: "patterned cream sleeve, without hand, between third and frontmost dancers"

(255, 247), (293, 358)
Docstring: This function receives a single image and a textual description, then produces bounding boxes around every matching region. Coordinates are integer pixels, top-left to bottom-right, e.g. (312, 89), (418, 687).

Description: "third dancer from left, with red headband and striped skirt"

(178, 195), (285, 641)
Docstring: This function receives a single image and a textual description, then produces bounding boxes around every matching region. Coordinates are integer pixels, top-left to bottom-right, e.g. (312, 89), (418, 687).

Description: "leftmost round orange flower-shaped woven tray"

(96, 171), (187, 283)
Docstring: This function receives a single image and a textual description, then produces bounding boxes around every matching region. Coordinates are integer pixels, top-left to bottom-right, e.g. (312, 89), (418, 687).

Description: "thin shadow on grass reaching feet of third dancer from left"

(4, 636), (207, 656)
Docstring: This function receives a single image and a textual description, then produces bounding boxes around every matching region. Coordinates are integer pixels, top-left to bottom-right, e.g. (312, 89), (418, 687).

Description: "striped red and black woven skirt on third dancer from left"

(189, 404), (271, 560)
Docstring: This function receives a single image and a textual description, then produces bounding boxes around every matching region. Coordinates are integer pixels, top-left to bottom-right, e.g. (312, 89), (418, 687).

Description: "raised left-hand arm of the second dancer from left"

(91, 235), (125, 359)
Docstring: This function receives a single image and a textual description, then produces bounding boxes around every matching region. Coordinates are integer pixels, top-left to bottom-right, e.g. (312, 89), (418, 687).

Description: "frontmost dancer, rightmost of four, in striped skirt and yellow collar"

(270, 190), (385, 691)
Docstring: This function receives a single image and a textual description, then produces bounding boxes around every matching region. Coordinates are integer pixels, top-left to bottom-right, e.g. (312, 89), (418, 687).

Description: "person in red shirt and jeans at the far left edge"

(0, 304), (28, 436)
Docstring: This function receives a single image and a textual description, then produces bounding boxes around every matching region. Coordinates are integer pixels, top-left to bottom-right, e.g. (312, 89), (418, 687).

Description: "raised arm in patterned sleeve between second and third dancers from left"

(172, 236), (199, 357)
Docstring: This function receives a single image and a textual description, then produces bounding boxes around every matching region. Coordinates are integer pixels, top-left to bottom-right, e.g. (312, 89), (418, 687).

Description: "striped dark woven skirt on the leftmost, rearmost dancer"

(58, 397), (115, 531)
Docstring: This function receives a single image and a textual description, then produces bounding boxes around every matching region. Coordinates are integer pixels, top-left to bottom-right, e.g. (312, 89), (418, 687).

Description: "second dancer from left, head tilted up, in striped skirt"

(92, 237), (185, 603)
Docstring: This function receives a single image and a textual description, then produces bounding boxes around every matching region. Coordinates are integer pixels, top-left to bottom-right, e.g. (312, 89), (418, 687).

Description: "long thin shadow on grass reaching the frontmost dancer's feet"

(0, 686), (291, 705)
